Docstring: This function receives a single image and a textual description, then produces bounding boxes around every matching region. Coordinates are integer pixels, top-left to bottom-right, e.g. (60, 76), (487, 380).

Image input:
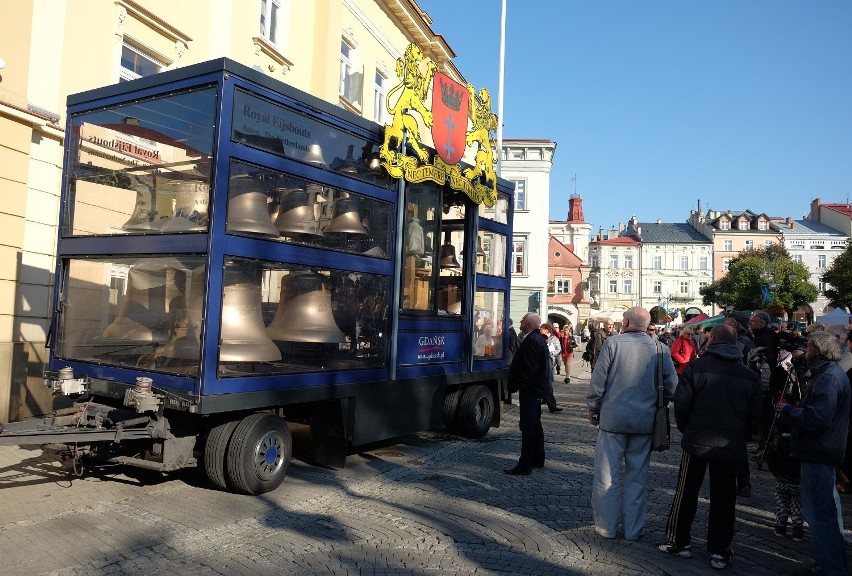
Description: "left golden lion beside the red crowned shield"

(380, 44), (437, 163)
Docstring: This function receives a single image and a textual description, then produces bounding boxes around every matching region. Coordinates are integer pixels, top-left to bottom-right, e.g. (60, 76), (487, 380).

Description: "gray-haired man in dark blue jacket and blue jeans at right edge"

(778, 331), (852, 576)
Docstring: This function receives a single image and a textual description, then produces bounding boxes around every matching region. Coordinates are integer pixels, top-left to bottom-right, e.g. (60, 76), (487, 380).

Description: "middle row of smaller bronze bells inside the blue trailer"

(122, 177), (367, 237)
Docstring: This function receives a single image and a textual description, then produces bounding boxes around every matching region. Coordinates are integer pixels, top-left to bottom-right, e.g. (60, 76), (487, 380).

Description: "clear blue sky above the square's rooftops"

(417, 0), (852, 231)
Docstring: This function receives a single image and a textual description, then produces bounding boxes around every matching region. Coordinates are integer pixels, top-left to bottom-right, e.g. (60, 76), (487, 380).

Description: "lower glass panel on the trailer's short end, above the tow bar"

(55, 255), (207, 376)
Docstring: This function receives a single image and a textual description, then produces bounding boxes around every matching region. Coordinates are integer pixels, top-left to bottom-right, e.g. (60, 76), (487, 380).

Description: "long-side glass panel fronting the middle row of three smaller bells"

(226, 160), (393, 258)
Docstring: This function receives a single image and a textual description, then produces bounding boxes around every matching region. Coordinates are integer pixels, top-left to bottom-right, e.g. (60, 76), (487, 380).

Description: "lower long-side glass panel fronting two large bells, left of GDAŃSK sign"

(219, 258), (390, 377)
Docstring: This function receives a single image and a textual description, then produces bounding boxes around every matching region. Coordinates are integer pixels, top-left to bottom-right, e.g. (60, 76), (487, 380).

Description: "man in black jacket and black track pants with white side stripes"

(657, 324), (760, 569)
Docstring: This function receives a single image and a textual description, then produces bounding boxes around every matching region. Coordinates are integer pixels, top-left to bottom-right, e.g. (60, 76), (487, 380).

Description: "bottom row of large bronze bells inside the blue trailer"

(103, 264), (346, 362)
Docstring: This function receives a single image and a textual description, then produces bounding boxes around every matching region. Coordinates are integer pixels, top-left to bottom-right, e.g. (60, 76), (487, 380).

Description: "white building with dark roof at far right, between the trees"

(772, 218), (849, 321)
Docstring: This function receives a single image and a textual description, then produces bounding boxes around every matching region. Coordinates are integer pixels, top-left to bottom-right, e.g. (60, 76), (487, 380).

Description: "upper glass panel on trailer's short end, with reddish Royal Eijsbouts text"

(63, 88), (216, 236)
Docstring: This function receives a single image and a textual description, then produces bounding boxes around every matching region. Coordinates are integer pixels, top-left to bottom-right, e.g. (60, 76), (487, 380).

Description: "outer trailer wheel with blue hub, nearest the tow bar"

(226, 413), (293, 494)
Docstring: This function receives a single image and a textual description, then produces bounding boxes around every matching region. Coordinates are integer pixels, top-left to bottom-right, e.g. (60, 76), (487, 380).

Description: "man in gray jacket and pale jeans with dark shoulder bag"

(586, 306), (677, 540)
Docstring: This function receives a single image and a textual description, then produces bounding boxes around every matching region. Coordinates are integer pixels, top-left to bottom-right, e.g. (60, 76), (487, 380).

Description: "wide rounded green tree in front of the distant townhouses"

(701, 245), (819, 317)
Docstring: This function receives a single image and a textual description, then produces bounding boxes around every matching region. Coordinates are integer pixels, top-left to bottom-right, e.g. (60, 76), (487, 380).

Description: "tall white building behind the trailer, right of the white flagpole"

(500, 140), (556, 327)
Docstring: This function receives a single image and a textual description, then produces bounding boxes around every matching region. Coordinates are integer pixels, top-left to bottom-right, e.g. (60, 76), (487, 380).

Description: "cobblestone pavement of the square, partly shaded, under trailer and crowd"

(0, 360), (852, 576)
